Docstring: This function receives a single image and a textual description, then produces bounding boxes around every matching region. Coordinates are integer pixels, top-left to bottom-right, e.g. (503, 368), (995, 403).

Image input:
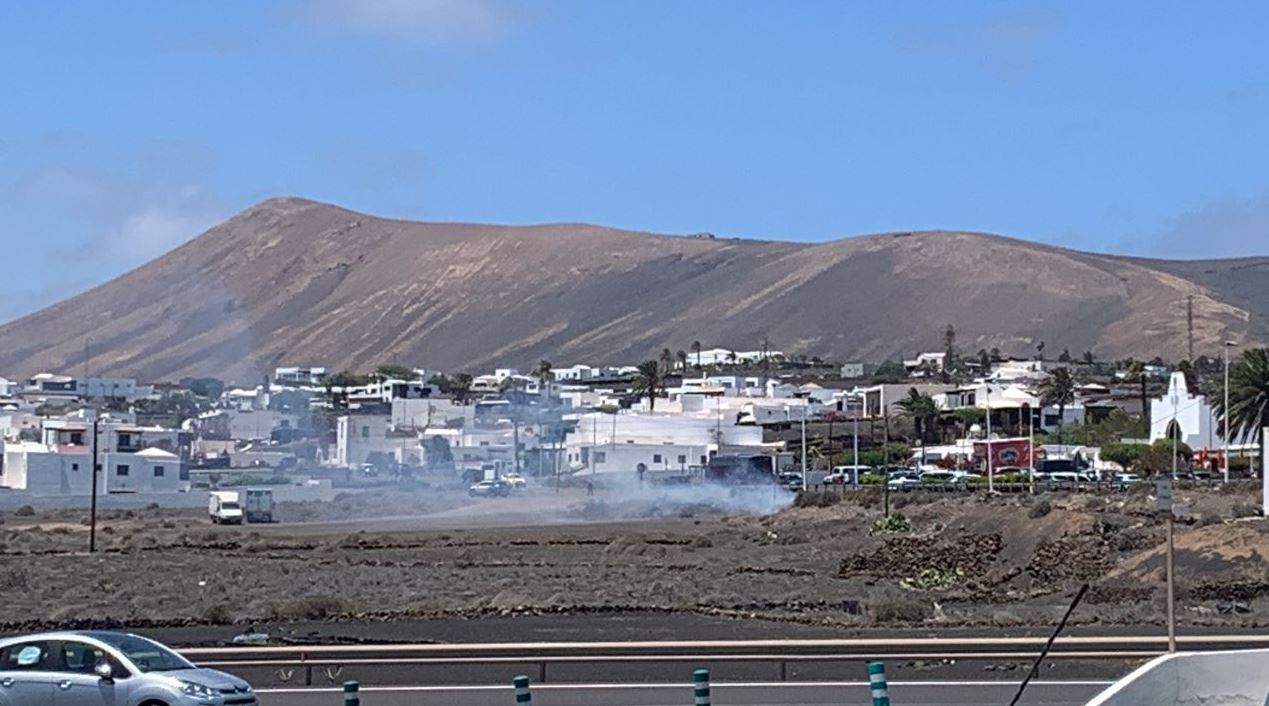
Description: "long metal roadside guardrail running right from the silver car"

(183, 635), (1269, 686)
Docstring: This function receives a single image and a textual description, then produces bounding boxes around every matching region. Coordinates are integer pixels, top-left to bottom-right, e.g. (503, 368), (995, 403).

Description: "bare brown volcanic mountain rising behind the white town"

(0, 198), (1269, 381)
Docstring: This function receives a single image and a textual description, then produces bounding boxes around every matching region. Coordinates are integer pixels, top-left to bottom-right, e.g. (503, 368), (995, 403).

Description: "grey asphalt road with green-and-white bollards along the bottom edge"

(259, 681), (1112, 706)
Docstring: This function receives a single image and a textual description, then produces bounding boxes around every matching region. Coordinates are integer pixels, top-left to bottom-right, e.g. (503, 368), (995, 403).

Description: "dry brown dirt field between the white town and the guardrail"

(0, 486), (1269, 640)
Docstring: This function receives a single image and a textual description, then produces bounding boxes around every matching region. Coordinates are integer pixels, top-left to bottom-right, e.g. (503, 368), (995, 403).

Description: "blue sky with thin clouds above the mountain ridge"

(0, 0), (1269, 320)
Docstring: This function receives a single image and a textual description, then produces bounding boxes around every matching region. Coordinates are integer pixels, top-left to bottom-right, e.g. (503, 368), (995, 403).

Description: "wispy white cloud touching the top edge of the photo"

(298, 0), (522, 44)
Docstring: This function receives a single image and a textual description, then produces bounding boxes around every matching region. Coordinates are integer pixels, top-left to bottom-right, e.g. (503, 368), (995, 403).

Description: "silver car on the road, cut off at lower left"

(0, 630), (258, 706)
